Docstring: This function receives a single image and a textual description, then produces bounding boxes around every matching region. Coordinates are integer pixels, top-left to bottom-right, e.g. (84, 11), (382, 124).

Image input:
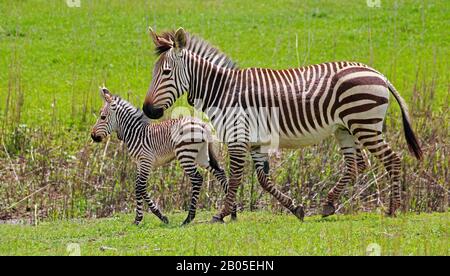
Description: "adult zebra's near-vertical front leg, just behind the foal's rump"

(211, 142), (248, 223)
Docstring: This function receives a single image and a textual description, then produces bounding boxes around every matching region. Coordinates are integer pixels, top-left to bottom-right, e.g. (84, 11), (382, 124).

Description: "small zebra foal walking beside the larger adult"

(91, 87), (236, 225)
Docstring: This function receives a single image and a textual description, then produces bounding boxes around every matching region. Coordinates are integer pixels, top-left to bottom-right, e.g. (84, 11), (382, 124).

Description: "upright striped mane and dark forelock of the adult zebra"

(155, 31), (238, 69)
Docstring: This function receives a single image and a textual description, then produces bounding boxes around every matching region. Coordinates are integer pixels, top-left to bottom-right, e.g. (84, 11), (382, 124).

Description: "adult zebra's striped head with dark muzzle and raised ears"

(142, 28), (189, 119)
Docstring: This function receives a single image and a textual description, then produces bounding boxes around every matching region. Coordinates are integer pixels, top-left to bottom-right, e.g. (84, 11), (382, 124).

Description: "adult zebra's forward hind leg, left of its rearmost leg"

(322, 129), (362, 217)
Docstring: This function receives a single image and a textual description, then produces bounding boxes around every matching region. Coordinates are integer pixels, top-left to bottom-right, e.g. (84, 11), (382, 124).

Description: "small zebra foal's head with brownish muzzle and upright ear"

(91, 87), (117, 143)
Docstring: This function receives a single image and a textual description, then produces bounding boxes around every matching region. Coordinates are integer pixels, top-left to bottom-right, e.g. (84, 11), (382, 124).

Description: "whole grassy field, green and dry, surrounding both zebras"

(0, 0), (450, 255)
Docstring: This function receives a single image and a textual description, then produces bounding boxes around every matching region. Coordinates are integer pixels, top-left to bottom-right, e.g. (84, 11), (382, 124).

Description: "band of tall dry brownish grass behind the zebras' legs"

(0, 96), (450, 219)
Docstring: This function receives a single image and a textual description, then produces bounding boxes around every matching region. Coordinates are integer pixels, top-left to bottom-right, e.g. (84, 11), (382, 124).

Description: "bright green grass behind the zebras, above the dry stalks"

(0, 0), (450, 127)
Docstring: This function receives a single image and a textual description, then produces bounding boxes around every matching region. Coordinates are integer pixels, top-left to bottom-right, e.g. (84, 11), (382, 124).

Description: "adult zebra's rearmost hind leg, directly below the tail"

(358, 135), (401, 216)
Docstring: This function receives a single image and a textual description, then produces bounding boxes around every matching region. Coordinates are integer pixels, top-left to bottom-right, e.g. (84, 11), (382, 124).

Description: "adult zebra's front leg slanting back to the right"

(251, 147), (305, 221)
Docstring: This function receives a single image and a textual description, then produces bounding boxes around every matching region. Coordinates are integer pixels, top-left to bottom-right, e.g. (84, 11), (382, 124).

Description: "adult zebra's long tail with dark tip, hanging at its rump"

(386, 79), (423, 160)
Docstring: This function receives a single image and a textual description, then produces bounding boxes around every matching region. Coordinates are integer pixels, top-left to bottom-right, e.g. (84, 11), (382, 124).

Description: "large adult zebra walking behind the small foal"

(143, 28), (422, 222)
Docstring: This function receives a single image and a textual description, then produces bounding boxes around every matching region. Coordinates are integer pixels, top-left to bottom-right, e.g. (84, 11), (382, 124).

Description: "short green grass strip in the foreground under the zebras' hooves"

(0, 212), (450, 255)
